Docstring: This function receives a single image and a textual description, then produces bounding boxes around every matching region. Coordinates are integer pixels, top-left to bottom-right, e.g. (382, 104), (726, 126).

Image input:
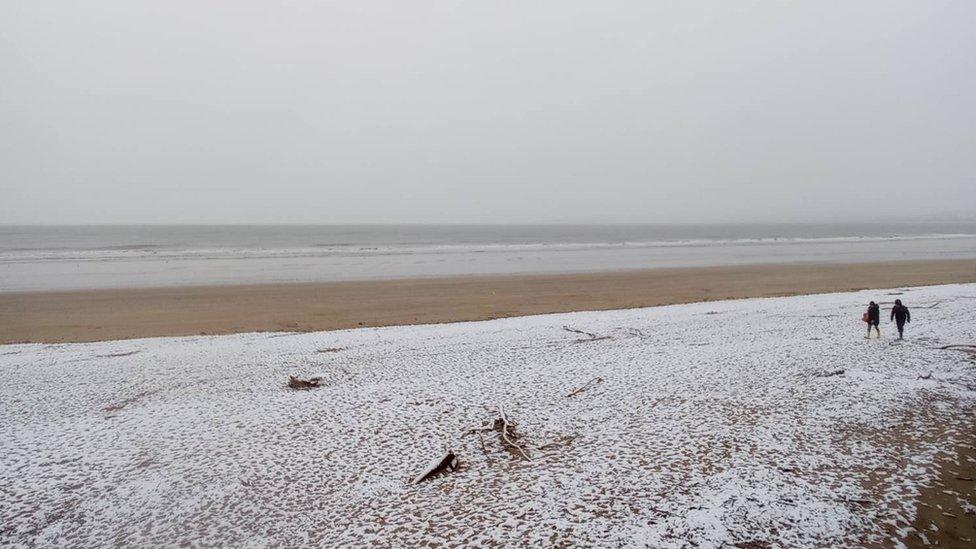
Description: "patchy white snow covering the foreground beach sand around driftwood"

(0, 285), (976, 547)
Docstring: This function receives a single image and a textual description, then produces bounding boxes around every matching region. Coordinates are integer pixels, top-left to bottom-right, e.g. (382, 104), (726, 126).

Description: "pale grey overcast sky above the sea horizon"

(0, 0), (976, 223)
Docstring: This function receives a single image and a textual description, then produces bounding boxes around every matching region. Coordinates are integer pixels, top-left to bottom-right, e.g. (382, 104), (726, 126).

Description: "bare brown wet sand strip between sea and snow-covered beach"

(0, 260), (976, 343)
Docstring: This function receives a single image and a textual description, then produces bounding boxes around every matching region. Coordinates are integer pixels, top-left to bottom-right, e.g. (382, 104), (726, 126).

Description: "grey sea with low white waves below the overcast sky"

(0, 223), (976, 291)
